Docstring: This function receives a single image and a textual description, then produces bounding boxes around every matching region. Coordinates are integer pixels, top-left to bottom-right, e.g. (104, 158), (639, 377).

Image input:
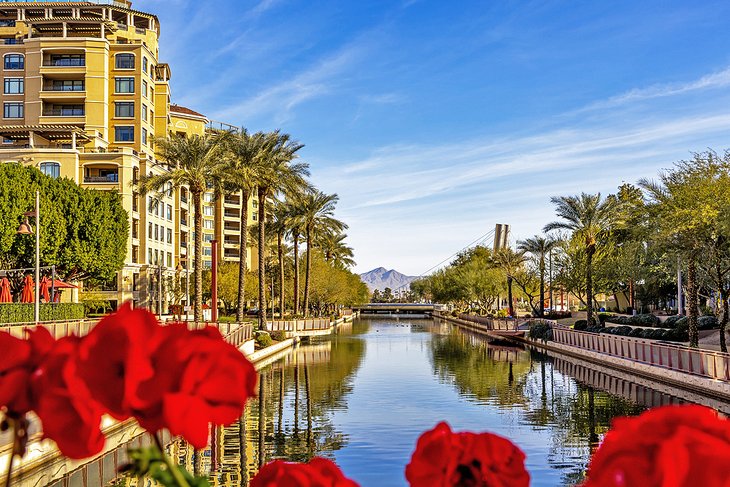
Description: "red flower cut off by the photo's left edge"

(0, 327), (54, 416)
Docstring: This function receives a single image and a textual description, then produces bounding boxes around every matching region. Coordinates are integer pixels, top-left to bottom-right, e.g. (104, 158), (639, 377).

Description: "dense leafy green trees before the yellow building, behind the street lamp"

(0, 163), (129, 281)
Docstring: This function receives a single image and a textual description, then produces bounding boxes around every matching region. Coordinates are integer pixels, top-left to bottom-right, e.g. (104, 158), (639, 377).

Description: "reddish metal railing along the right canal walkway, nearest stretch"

(553, 326), (730, 381)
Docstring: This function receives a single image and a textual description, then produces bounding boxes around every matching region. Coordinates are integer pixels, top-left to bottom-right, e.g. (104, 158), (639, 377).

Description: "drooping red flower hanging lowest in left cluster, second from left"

(32, 336), (104, 458)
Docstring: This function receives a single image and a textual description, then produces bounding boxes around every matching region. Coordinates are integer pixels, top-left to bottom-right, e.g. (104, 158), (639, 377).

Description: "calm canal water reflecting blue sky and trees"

(172, 318), (700, 486)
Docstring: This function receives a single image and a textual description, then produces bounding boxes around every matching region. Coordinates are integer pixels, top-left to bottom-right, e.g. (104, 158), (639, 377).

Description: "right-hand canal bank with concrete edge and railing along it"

(435, 314), (730, 405)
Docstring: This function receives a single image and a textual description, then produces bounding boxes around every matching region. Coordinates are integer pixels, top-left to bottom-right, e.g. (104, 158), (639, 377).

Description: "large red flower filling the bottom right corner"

(583, 405), (730, 487)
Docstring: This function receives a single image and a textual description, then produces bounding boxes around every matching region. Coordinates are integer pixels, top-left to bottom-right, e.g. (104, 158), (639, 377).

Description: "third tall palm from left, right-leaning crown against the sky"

(256, 130), (309, 330)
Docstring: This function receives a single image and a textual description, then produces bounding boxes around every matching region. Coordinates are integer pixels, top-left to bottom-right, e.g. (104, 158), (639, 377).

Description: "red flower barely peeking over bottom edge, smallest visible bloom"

(251, 458), (358, 487)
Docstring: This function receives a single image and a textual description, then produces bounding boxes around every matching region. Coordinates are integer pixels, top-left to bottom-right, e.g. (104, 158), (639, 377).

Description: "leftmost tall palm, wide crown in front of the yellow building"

(139, 134), (223, 323)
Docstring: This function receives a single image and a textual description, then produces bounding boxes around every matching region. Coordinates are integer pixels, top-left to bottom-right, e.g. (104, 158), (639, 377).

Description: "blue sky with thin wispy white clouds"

(134, 0), (730, 274)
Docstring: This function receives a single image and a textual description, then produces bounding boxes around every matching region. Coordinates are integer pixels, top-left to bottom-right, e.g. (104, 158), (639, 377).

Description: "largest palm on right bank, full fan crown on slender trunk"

(543, 193), (620, 326)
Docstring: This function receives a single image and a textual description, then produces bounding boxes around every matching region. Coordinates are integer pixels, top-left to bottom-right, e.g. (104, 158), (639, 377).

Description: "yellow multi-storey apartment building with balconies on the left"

(0, 0), (253, 311)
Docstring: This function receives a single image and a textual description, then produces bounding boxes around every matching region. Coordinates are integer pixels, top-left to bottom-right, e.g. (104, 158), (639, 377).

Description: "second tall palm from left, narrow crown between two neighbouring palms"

(221, 129), (266, 322)
